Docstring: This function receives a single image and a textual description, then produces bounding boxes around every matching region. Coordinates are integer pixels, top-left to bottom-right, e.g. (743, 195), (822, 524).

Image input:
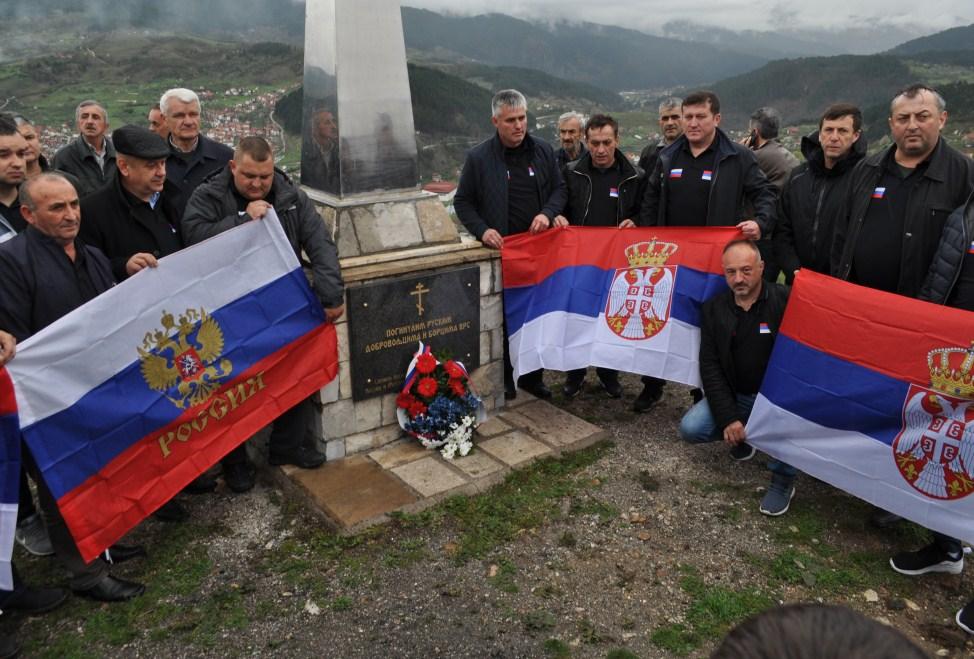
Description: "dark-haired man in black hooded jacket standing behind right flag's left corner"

(774, 103), (866, 284)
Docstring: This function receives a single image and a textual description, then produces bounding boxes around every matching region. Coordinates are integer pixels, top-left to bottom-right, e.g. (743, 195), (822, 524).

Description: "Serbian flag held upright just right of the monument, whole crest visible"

(501, 227), (741, 385)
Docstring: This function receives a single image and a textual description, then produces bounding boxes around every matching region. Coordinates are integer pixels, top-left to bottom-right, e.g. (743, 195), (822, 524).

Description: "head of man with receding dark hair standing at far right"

(889, 85), (947, 160)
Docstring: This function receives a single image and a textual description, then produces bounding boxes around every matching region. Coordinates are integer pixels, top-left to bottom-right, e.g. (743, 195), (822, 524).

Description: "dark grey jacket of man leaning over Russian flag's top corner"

(182, 167), (345, 309)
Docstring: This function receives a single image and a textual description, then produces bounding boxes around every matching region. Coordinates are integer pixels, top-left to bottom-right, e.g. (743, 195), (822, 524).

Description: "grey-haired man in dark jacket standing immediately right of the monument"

(453, 89), (567, 399)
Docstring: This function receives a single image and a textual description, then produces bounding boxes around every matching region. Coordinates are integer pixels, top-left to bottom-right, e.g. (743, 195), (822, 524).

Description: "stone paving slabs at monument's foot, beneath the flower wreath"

(273, 398), (606, 533)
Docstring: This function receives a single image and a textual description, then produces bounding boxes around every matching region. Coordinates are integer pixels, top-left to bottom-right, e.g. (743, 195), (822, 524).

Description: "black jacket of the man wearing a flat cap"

(81, 175), (183, 281)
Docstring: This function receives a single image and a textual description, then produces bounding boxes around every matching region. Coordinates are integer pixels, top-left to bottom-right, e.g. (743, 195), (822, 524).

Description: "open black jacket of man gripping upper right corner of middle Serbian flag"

(637, 128), (777, 236)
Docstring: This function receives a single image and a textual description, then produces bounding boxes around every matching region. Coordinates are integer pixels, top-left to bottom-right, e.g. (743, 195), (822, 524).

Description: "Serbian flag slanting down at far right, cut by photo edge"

(747, 270), (974, 542)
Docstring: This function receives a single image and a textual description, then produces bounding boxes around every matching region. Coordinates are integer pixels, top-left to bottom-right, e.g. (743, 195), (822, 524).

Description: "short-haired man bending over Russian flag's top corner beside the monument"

(183, 137), (345, 484)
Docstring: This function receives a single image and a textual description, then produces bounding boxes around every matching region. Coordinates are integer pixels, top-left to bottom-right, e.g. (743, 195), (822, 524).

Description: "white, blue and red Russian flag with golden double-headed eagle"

(7, 212), (338, 560)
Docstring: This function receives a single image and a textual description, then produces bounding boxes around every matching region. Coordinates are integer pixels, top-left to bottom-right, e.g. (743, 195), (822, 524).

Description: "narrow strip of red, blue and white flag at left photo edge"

(0, 368), (20, 590)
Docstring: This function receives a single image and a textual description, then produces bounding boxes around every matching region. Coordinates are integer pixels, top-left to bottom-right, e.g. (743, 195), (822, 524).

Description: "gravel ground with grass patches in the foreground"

(7, 374), (974, 659)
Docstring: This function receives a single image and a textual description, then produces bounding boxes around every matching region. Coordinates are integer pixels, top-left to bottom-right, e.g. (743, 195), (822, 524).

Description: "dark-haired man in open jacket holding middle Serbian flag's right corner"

(633, 91), (777, 412)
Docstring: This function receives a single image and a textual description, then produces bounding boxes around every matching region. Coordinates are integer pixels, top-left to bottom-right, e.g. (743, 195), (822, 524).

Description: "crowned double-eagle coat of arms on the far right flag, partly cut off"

(893, 343), (974, 499)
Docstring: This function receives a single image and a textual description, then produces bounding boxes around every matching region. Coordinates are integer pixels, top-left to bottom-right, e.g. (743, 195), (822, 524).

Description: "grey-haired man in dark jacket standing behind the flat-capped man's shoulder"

(53, 100), (115, 197)
